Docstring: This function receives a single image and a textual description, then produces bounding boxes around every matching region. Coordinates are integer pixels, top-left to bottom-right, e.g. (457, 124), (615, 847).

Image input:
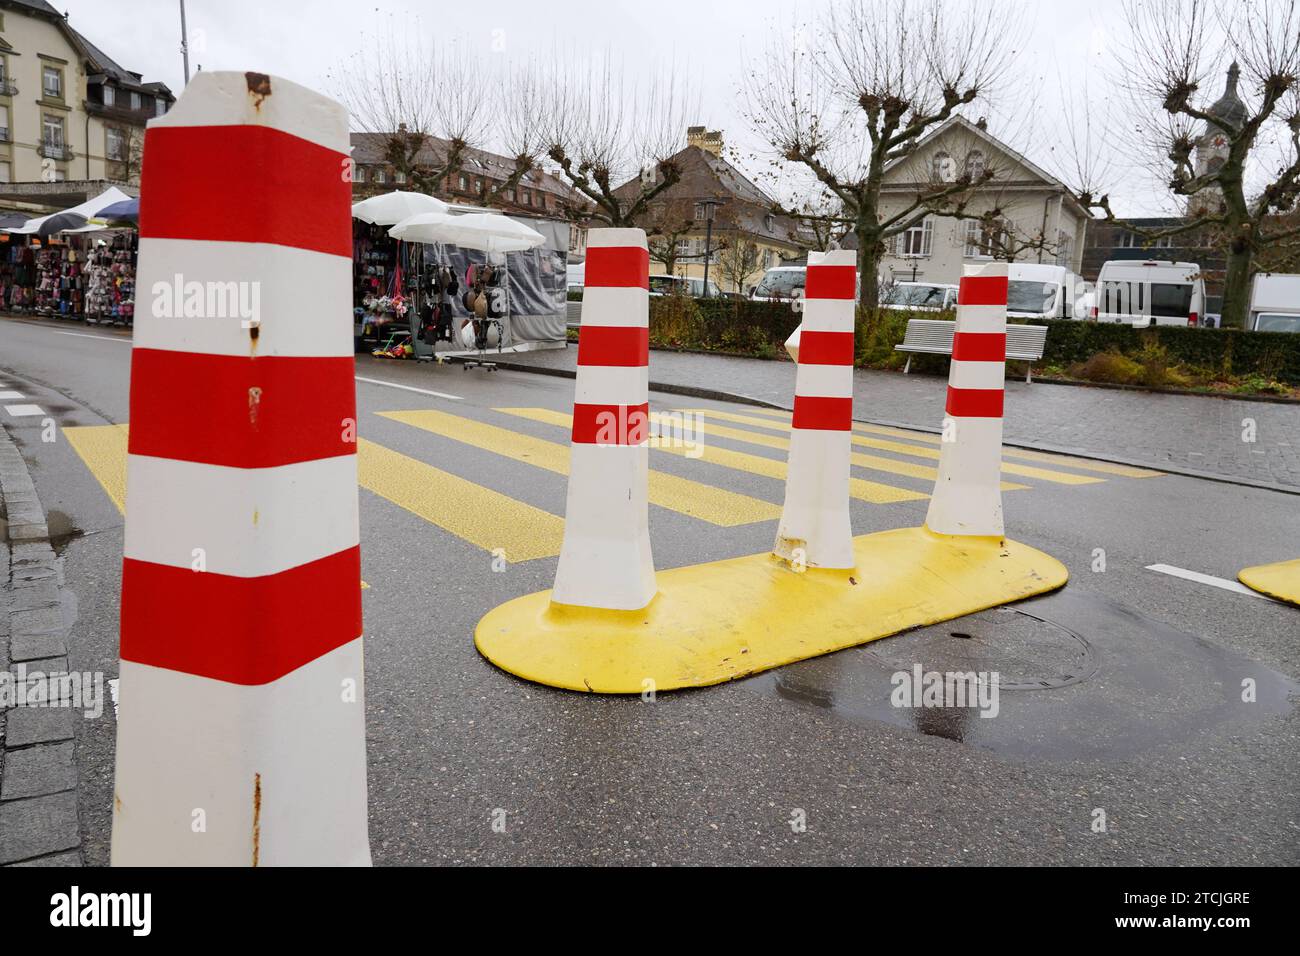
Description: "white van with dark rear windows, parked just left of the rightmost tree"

(1092, 259), (1205, 329)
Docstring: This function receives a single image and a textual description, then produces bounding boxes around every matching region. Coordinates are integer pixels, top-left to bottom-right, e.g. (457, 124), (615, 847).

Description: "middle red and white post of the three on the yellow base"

(772, 250), (857, 568)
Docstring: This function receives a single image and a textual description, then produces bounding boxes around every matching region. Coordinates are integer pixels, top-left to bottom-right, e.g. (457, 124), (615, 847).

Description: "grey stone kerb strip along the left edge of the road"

(0, 427), (82, 866)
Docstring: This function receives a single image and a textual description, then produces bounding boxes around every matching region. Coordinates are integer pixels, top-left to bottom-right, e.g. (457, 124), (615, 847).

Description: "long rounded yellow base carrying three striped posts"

(475, 528), (1069, 693)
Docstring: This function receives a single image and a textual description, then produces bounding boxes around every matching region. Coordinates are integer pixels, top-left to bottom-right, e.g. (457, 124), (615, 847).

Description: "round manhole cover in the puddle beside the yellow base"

(868, 607), (1097, 691)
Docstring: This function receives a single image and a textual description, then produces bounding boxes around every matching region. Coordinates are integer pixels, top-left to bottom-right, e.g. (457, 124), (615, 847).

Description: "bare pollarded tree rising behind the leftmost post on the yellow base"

(542, 56), (692, 226)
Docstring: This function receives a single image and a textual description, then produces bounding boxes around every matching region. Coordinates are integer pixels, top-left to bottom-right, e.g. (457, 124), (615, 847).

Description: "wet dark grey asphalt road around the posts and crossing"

(0, 321), (1300, 865)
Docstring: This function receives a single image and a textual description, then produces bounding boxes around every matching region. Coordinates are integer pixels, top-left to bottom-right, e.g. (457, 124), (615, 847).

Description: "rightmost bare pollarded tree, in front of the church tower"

(1079, 0), (1300, 326)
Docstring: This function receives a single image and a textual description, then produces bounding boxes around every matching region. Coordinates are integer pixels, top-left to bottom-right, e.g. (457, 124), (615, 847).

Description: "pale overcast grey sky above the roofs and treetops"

(56, 0), (1248, 215)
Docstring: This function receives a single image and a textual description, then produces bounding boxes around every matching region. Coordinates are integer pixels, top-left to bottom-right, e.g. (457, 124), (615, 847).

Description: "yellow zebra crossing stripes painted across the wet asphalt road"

(64, 408), (1162, 574)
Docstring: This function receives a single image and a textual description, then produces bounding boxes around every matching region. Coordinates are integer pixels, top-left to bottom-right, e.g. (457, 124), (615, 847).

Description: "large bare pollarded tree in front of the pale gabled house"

(746, 0), (1022, 304)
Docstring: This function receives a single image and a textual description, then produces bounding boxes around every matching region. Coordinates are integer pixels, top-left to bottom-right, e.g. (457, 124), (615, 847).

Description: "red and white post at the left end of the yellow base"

(551, 229), (655, 610)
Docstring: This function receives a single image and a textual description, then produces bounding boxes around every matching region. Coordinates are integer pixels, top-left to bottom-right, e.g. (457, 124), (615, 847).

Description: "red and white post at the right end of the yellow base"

(926, 263), (1006, 537)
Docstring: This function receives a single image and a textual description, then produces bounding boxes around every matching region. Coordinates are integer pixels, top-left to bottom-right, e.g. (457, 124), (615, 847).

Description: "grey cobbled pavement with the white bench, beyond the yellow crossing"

(488, 346), (1300, 488)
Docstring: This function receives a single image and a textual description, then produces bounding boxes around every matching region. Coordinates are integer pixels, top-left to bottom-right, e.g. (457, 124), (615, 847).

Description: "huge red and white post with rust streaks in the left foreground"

(112, 72), (371, 866)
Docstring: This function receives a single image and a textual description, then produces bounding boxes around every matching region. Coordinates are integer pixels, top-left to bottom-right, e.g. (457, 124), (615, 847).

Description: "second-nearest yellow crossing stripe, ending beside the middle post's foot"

(380, 410), (781, 528)
